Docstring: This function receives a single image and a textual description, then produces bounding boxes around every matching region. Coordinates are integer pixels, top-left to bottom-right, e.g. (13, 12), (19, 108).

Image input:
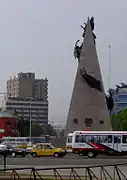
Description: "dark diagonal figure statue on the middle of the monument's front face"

(80, 68), (102, 92)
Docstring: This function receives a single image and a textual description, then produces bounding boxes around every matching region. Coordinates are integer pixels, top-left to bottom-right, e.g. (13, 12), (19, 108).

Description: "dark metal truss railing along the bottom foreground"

(0, 163), (127, 180)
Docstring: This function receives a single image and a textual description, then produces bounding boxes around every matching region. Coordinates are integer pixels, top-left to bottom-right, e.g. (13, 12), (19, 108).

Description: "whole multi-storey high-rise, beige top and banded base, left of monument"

(6, 73), (48, 124)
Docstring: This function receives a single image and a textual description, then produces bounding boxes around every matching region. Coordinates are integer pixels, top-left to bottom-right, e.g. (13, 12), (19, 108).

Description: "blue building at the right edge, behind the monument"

(111, 83), (127, 114)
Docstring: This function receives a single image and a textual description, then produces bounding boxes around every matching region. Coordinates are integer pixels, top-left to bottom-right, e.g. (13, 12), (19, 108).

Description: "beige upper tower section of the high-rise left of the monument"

(7, 72), (48, 101)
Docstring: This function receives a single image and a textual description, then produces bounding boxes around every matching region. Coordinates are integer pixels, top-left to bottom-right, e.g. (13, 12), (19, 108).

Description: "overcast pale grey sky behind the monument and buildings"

(0, 0), (127, 125)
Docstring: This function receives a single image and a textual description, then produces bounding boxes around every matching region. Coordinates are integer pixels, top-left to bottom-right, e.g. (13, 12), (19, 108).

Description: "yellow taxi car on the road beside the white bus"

(31, 143), (66, 158)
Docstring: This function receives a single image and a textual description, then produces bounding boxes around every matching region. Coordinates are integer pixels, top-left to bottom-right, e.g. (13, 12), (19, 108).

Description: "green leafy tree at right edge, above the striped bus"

(111, 108), (127, 131)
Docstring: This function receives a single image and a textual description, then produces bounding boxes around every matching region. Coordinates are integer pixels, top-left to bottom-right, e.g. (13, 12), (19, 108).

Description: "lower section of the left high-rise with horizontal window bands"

(6, 98), (48, 124)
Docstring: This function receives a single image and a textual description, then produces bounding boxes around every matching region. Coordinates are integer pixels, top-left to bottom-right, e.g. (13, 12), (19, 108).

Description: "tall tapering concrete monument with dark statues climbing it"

(65, 17), (111, 136)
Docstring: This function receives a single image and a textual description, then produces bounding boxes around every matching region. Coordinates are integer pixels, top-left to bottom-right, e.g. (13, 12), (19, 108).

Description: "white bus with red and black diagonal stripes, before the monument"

(66, 131), (127, 158)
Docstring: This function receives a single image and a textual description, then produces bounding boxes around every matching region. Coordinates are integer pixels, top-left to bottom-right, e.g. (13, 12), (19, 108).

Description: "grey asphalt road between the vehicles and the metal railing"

(0, 156), (127, 167)
